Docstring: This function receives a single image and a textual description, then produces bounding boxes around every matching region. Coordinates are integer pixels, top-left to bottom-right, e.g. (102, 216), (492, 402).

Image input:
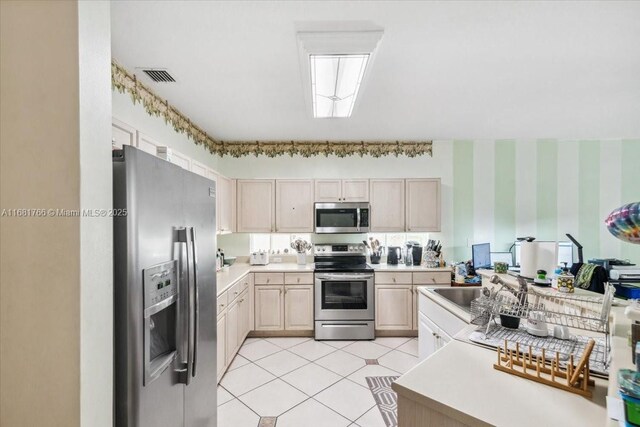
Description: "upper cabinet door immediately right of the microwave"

(369, 179), (404, 231)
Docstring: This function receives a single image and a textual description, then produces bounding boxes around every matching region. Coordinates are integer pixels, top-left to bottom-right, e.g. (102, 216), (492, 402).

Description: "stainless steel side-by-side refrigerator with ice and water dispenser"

(113, 146), (217, 427)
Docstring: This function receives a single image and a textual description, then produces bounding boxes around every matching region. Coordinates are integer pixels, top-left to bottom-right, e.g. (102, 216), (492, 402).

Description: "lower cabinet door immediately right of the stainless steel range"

(376, 285), (413, 330)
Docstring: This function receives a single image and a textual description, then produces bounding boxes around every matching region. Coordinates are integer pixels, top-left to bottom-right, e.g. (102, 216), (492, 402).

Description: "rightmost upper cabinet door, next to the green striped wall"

(406, 178), (440, 232)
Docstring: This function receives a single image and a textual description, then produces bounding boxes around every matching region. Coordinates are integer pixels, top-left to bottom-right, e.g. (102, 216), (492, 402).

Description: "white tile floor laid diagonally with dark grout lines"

(218, 337), (418, 427)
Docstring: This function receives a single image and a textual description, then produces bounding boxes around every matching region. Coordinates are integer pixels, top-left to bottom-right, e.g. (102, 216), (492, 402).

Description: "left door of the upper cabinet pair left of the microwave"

(237, 180), (275, 233)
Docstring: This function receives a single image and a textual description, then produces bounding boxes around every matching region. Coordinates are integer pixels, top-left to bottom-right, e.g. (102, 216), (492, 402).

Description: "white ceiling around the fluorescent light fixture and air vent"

(111, 1), (640, 140)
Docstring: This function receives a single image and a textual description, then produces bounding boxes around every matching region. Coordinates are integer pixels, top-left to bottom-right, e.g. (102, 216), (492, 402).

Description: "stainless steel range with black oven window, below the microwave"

(314, 243), (375, 340)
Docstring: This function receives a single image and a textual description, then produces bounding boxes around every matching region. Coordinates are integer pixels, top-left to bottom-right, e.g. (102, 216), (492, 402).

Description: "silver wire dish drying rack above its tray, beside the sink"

(471, 276), (615, 366)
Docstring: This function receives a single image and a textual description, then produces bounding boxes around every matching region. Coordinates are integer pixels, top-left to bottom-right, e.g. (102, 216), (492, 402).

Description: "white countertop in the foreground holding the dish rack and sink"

(393, 271), (633, 426)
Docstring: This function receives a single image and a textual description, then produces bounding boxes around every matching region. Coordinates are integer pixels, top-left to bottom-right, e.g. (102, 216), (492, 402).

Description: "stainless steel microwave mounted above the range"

(315, 203), (370, 234)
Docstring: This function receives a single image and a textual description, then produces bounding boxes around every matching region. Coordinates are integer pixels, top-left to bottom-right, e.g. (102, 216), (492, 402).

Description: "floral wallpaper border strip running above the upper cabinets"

(111, 60), (433, 157)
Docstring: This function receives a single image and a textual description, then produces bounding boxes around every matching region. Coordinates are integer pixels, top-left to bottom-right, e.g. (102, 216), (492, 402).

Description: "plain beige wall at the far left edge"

(0, 1), (111, 427)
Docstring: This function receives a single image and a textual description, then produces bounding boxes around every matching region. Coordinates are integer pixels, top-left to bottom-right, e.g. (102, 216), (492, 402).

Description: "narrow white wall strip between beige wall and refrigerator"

(78, 1), (113, 427)
